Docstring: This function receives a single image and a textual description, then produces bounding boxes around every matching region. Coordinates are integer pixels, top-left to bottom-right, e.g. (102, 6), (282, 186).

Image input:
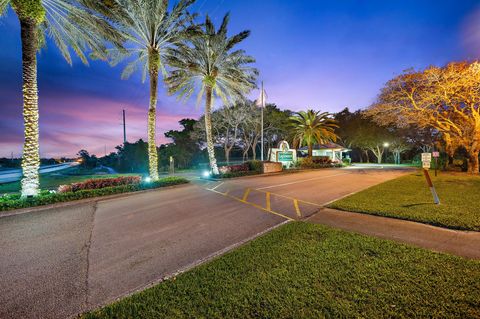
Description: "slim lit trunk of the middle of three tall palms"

(148, 52), (159, 181)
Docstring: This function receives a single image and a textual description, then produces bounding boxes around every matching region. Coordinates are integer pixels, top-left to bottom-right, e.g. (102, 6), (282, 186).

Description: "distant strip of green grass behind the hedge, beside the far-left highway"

(0, 169), (140, 194)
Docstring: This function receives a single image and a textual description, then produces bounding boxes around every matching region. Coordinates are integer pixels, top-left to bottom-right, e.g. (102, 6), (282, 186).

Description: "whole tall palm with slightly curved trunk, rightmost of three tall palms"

(165, 14), (258, 174)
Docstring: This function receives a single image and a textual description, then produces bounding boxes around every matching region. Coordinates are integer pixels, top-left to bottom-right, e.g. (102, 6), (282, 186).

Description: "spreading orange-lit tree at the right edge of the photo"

(367, 62), (480, 174)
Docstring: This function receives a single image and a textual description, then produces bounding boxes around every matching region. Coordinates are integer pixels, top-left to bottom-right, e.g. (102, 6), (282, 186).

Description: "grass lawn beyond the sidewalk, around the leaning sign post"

(329, 173), (480, 231)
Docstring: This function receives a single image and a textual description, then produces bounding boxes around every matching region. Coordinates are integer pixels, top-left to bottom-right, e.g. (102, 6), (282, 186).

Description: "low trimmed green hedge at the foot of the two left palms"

(0, 177), (189, 211)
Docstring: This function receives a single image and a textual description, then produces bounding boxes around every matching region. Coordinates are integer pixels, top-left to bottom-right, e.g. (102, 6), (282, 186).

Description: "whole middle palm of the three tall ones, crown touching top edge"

(92, 0), (195, 180)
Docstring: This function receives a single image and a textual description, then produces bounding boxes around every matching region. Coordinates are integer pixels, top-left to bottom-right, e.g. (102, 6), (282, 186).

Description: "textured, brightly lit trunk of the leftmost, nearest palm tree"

(20, 18), (40, 197)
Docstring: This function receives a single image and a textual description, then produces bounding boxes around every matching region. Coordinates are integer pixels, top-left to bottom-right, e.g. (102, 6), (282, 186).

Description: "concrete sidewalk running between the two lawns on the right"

(305, 208), (480, 259)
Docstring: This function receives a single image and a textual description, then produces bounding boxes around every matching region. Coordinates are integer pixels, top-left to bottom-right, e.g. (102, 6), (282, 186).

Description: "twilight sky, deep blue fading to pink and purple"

(0, 0), (480, 157)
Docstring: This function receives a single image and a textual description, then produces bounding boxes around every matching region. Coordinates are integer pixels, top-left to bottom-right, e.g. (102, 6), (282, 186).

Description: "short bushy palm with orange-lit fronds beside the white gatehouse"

(290, 110), (338, 159)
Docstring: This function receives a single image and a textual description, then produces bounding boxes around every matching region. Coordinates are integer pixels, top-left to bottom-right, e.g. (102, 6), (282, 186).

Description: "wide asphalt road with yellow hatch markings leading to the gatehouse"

(0, 169), (405, 318)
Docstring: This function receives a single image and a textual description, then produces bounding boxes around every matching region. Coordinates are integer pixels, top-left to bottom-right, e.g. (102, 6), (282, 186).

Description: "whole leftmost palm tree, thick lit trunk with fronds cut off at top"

(0, 0), (121, 197)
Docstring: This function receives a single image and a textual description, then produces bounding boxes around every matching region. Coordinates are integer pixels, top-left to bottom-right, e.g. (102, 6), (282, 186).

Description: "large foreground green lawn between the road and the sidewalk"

(84, 222), (480, 319)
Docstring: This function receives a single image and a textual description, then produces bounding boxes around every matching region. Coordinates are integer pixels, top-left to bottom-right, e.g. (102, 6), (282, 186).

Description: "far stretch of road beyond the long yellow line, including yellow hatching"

(206, 168), (411, 219)
